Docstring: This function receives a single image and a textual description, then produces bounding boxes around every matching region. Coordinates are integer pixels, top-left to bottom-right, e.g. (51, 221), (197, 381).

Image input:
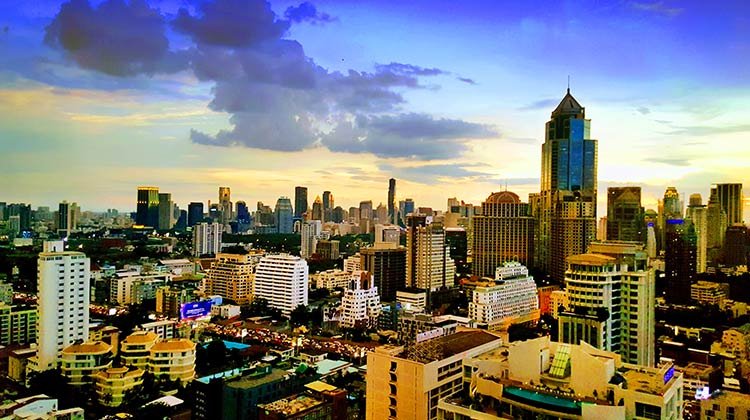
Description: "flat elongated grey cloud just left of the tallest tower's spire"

(322, 113), (499, 160)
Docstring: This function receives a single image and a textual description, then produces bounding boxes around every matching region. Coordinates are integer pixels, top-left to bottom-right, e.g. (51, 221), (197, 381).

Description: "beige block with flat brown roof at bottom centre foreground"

(366, 330), (501, 420)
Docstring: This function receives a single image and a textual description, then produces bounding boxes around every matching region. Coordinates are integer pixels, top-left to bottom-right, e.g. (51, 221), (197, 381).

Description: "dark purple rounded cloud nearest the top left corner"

(44, 0), (186, 76)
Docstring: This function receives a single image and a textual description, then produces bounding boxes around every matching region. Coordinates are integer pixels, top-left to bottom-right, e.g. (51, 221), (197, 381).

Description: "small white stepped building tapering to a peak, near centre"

(339, 271), (381, 329)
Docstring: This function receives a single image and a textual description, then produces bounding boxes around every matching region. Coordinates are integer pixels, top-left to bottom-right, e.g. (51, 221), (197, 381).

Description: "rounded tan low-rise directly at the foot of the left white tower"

(60, 341), (112, 385)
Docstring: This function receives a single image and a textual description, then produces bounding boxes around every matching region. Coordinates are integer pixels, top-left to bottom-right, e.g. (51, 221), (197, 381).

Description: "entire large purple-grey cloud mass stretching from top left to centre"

(48, 0), (488, 159)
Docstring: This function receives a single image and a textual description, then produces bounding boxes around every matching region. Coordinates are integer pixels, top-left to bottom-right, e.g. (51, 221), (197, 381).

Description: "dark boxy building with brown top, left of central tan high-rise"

(360, 243), (406, 302)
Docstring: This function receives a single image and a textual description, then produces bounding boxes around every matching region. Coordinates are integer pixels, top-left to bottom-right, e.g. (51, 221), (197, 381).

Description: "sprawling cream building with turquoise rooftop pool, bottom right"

(438, 337), (683, 420)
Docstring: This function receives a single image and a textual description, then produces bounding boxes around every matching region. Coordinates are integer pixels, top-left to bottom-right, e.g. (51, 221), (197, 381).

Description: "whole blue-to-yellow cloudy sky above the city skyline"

(0, 0), (750, 216)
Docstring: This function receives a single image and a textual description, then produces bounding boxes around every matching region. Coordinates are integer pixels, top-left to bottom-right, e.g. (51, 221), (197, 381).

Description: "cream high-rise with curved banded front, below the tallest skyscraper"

(558, 241), (656, 366)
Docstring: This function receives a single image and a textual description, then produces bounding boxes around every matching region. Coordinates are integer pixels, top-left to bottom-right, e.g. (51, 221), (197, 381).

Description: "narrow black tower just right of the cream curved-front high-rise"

(664, 219), (697, 305)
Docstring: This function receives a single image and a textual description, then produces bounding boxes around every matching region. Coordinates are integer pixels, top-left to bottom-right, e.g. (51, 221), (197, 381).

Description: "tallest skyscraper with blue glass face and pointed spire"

(529, 89), (597, 281)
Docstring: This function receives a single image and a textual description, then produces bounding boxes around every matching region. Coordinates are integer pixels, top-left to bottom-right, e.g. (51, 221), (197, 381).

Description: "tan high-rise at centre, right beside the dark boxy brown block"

(406, 223), (456, 292)
